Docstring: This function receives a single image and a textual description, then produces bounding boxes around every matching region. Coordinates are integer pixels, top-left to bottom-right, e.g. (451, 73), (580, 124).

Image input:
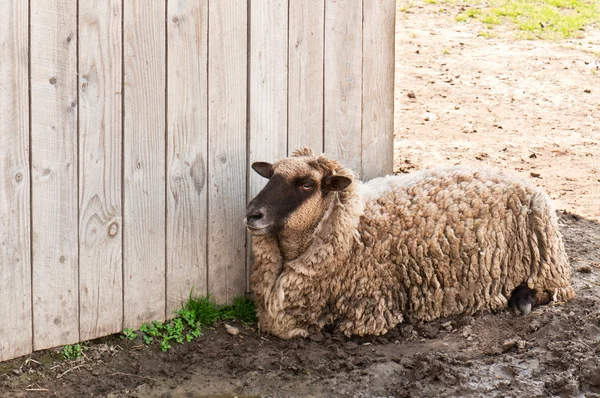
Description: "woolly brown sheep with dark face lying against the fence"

(245, 148), (575, 339)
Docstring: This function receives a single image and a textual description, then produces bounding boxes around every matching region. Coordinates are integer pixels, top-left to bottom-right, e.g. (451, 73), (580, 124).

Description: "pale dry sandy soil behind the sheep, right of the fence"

(395, 1), (600, 221)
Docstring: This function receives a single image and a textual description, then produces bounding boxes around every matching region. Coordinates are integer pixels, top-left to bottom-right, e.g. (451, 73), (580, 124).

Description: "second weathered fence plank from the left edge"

(30, 0), (79, 350)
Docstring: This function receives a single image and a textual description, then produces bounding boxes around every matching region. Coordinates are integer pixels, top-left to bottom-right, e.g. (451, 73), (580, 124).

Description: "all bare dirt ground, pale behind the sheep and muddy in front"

(0, 5), (600, 397)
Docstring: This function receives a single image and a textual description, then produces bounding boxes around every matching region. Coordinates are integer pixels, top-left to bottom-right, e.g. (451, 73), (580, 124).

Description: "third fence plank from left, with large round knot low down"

(79, 0), (123, 340)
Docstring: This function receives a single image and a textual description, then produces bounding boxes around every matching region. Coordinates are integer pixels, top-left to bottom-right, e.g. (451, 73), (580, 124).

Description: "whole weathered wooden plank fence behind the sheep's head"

(0, 0), (395, 360)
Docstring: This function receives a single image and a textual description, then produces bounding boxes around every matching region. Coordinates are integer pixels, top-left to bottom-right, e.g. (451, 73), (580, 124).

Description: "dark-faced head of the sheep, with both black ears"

(246, 148), (352, 235)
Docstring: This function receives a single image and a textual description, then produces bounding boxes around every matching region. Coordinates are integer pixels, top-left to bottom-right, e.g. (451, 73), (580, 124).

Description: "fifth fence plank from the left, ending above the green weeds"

(167, 0), (208, 317)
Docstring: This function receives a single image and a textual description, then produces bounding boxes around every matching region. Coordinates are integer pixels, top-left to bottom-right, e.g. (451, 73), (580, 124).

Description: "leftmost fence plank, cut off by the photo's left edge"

(0, 0), (32, 361)
